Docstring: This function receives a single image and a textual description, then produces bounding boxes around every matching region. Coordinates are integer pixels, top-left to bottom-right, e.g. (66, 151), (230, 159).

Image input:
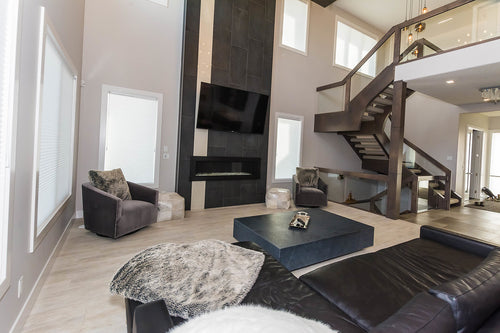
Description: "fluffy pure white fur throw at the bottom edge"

(169, 305), (338, 333)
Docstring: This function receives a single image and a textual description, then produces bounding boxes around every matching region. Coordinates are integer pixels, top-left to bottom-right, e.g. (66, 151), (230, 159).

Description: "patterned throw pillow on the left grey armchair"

(89, 169), (132, 200)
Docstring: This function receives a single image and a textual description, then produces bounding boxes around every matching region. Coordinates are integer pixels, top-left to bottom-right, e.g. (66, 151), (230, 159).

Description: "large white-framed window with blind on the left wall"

(31, 8), (77, 251)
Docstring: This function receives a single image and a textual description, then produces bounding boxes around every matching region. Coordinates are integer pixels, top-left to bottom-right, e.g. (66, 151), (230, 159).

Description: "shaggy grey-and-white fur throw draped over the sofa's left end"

(110, 240), (264, 319)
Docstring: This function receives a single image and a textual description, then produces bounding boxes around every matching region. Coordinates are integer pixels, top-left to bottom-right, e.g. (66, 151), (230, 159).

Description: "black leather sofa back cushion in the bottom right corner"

(430, 249), (500, 333)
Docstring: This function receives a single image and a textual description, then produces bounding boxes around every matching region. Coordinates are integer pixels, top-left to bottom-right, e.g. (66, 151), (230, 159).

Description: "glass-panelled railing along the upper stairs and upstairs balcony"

(316, 0), (500, 113)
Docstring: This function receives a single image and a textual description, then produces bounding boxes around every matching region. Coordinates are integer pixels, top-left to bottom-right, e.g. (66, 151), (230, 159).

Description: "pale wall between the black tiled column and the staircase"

(267, 0), (383, 188)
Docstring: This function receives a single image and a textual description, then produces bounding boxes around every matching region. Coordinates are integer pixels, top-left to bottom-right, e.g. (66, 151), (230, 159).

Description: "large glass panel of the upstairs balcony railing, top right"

(401, 0), (500, 62)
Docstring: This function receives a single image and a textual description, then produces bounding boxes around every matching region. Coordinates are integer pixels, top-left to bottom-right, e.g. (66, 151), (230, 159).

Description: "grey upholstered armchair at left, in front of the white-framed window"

(82, 182), (158, 238)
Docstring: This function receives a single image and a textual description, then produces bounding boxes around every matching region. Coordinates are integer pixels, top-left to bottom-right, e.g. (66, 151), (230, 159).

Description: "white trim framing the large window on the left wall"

(29, 6), (78, 253)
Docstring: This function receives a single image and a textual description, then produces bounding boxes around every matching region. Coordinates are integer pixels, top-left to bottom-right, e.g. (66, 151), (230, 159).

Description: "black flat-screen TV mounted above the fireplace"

(196, 82), (269, 134)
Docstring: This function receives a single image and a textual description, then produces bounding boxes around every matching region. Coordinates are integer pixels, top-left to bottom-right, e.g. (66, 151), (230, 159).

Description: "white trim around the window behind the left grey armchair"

(99, 84), (163, 188)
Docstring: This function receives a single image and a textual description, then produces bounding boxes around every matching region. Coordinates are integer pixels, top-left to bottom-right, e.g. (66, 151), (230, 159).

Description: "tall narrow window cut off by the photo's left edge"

(0, 0), (19, 298)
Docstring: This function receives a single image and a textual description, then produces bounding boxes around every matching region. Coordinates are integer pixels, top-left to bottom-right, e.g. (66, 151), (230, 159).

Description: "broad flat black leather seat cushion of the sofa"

(300, 239), (484, 330)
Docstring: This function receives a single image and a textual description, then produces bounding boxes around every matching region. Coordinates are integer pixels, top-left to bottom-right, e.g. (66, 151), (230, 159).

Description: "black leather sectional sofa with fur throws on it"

(125, 226), (500, 333)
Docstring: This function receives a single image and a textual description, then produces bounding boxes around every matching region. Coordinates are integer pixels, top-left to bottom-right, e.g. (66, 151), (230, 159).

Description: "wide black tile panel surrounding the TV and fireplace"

(205, 0), (276, 208)
